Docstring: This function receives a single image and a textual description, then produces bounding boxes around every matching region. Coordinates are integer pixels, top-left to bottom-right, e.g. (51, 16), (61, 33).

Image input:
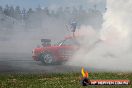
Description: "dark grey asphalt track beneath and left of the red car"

(0, 54), (81, 73)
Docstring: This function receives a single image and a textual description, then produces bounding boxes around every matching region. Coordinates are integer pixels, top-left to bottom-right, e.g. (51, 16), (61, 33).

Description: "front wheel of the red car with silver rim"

(40, 53), (54, 64)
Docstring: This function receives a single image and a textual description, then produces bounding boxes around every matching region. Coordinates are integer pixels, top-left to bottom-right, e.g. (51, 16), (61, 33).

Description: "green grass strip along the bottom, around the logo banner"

(0, 73), (132, 88)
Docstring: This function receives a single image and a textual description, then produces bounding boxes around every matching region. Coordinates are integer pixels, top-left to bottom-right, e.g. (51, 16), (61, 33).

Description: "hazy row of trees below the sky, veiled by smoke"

(0, 5), (102, 27)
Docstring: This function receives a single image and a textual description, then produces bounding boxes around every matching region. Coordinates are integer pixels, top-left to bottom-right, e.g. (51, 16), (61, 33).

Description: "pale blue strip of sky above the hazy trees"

(0, 0), (106, 11)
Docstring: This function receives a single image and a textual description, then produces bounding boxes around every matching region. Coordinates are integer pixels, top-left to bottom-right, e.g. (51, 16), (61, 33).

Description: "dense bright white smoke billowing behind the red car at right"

(68, 0), (132, 71)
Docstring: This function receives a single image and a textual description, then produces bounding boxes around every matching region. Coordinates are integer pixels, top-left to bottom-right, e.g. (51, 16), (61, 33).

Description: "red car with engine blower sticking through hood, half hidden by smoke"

(32, 37), (79, 64)
